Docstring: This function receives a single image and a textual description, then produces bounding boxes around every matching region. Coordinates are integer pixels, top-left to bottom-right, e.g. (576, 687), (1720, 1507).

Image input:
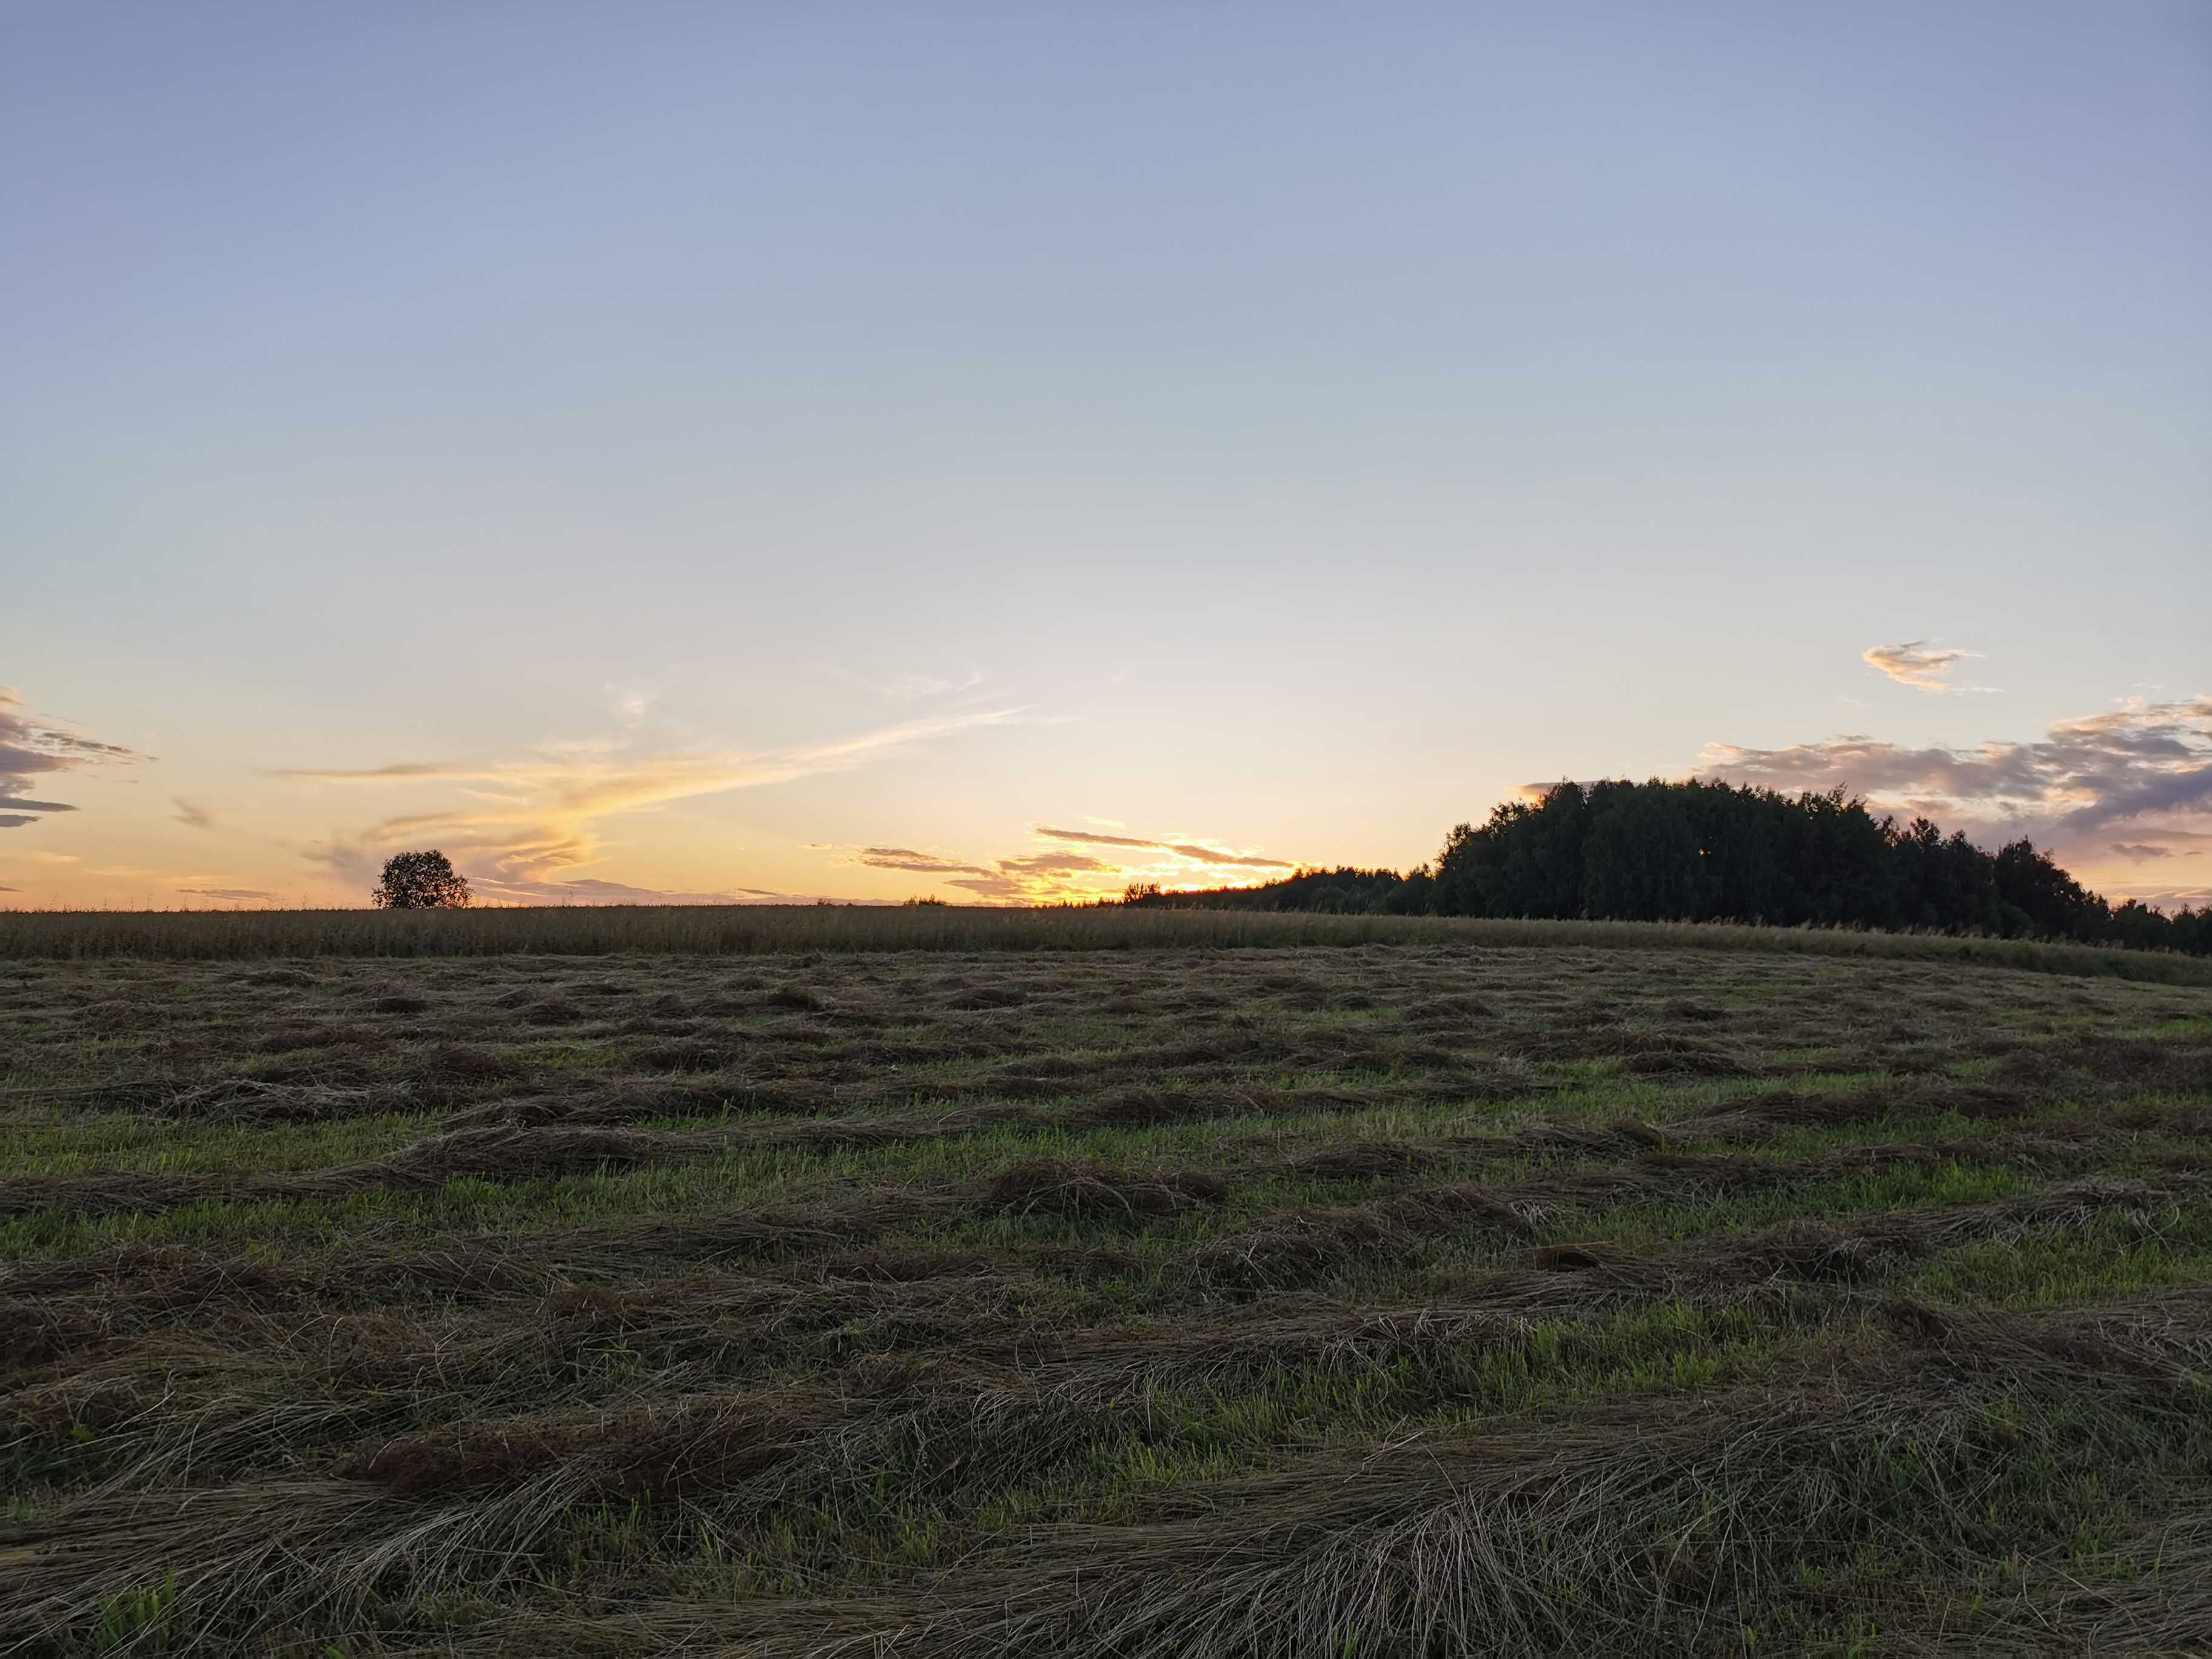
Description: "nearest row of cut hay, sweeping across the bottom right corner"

(444, 1294), (2212, 1659)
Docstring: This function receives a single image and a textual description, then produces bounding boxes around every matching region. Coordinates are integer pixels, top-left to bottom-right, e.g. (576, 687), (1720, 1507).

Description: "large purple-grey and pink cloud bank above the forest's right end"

(1697, 697), (2212, 876)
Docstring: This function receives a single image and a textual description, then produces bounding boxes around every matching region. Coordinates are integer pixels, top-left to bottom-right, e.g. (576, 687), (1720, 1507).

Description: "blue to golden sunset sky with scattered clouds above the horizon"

(0, 0), (2212, 907)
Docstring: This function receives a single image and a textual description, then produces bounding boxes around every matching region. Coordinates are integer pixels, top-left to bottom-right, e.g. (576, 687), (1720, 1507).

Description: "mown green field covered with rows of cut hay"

(0, 942), (2212, 1659)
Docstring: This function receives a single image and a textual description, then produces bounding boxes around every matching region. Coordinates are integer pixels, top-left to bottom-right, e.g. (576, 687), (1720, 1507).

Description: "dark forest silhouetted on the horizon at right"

(1124, 779), (2212, 956)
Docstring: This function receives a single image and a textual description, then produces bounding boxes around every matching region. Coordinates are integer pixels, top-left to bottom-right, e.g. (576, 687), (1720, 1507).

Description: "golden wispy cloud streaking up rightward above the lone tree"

(276, 708), (1022, 891)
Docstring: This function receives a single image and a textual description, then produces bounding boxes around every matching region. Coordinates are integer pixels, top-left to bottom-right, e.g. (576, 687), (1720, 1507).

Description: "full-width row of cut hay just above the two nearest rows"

(13, 1184), (2184, 1493)
